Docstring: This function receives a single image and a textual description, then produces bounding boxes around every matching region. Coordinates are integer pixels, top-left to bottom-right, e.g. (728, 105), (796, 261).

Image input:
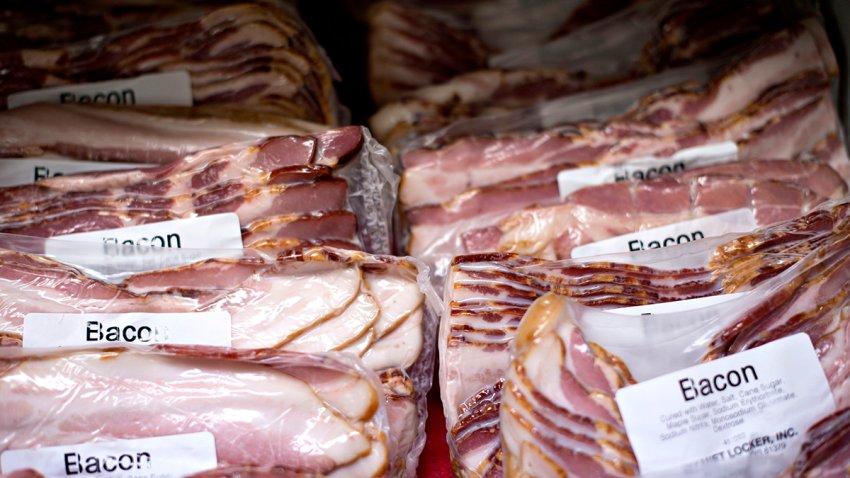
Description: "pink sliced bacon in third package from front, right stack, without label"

(463, 166), (832, 259)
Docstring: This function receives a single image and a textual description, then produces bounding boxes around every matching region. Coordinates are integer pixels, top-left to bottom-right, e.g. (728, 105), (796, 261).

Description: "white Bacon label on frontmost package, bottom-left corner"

(0, 432), (218, 478)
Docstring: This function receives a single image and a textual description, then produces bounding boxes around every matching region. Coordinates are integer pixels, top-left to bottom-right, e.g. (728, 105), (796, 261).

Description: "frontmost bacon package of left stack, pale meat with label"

(0, 346), (395, 477)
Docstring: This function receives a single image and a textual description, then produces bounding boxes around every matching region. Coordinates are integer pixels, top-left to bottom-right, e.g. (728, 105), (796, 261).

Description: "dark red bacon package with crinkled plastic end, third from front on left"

(0, 126), (398, 253)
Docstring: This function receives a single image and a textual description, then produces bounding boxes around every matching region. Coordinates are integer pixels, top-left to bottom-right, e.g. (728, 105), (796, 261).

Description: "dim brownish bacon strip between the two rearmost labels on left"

(0, 103), (324, 163)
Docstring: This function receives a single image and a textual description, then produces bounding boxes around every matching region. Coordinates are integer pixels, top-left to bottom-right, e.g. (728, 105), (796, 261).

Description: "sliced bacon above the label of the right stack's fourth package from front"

(400, 74), (838, 208)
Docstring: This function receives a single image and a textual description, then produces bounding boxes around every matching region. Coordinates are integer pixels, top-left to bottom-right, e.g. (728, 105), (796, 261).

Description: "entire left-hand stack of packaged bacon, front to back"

(0, 0), (439, 477)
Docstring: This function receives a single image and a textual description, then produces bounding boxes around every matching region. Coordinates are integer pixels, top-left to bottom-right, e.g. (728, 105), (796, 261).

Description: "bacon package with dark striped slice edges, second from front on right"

(438, 200), (848, 476)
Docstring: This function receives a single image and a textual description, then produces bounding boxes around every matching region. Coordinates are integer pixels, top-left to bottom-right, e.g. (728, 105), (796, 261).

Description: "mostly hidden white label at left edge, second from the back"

(0, 156), (150, 187)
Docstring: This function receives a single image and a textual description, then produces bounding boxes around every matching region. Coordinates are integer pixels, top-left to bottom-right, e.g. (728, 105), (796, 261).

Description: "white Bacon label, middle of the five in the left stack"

(45, 212), (242, 275)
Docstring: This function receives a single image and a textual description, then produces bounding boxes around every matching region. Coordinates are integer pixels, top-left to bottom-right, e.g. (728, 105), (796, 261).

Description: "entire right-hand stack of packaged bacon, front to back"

(370, 1), (850, 477)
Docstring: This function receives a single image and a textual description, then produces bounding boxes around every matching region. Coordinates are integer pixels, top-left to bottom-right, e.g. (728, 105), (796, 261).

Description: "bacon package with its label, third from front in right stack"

(407, 155), (847, 282)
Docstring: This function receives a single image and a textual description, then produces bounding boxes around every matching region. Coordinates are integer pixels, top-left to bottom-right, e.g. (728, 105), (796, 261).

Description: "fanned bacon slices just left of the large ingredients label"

(499, 295), (638, 477)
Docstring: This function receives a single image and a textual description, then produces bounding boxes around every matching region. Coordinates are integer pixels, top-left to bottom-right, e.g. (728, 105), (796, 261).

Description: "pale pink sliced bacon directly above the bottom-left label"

(0, 346), (392, 476)
